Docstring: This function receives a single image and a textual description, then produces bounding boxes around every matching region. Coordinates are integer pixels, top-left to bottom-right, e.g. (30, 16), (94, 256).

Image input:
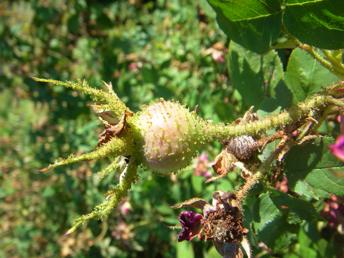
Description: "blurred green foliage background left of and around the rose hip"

(0, 0), (241, 258)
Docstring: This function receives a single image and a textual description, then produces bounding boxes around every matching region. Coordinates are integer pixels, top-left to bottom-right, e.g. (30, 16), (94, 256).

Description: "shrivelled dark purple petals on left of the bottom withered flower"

(178, 211), (203, 242)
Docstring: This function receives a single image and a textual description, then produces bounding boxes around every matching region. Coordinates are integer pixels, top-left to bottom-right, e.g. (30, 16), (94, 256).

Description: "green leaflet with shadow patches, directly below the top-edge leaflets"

(228, 42), (291, 111)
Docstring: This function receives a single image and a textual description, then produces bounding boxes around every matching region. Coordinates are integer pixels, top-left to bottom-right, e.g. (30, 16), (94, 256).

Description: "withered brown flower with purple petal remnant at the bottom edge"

(174, 191), (251, 257)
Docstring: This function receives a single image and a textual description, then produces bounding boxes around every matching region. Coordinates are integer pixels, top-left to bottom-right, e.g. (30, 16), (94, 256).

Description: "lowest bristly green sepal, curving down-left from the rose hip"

(66, 160), (137, 235)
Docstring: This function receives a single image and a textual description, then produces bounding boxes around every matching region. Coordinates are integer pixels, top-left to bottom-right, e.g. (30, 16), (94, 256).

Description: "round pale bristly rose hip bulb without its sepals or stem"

(136, 100), (204, 173)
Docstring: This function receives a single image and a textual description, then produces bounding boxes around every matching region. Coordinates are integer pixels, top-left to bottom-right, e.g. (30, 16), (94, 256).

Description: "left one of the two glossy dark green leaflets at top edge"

(208, 0), (282, 53)
